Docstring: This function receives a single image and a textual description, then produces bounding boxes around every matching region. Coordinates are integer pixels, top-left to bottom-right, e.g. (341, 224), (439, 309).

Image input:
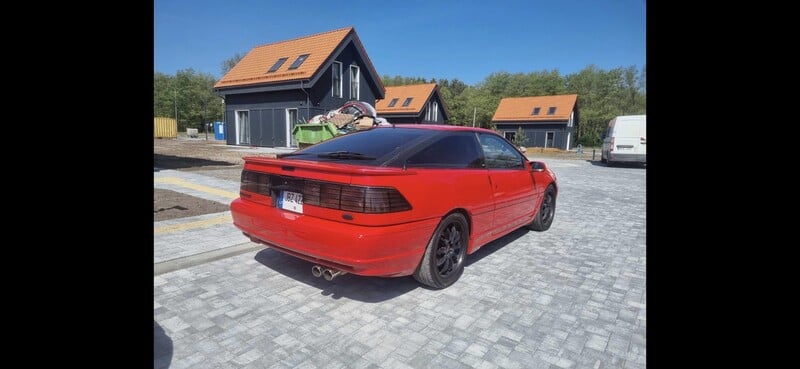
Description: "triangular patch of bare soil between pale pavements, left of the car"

(153, 188), (230, 221)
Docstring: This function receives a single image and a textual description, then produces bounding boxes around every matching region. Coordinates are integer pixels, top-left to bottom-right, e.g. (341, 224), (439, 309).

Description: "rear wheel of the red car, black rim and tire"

(414, 213), (469, 289)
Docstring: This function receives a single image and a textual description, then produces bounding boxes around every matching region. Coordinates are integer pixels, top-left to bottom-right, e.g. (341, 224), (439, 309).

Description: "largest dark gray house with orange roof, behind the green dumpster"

(214, 27), (385, 147)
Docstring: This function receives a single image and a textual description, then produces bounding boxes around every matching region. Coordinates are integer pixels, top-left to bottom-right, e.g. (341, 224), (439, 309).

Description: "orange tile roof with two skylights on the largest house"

(214, 27), (354, 88)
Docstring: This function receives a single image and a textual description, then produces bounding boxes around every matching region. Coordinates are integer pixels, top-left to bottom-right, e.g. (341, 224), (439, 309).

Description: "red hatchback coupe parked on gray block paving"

(231, 125), (558, 288)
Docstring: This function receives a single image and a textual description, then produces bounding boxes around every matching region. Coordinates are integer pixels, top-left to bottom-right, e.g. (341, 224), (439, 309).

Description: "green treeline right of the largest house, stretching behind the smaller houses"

(381, 65), (647, 146)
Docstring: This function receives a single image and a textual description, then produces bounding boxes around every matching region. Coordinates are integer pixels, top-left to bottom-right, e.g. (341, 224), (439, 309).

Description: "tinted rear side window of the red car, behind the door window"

(406, 133), (483, 169)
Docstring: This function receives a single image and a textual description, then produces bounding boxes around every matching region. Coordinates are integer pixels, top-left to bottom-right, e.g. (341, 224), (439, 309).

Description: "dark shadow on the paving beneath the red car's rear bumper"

(255, 248), (422, 303)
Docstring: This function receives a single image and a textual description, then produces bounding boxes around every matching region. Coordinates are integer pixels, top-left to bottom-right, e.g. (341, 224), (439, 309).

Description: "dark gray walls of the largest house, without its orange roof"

(216, 35), (384, 147)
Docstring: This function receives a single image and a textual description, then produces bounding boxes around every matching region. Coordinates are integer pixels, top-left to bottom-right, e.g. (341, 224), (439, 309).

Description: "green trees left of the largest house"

(153, 68), (222, 132)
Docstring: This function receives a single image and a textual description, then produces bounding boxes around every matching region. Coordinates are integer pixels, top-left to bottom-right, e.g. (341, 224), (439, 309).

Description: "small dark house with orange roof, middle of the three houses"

(375, 83), (450, 124)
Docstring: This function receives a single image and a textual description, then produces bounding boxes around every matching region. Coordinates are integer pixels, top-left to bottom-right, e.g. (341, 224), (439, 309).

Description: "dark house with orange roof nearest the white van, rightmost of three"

(492, 94), (579, 150)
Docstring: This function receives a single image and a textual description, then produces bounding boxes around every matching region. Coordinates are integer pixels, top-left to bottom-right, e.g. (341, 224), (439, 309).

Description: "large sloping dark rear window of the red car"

(282, 127), (436, 166)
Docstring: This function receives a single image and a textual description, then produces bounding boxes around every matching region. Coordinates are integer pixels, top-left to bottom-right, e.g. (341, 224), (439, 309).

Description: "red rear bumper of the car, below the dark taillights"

(231, 199), (438, 277)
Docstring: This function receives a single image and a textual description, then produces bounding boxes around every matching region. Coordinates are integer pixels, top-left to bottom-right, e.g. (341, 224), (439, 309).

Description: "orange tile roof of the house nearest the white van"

(492, 94), (578, 122)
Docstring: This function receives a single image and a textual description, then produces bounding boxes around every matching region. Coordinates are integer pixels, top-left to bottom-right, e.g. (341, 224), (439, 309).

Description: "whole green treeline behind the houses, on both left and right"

(153, 63), (647, 146)
